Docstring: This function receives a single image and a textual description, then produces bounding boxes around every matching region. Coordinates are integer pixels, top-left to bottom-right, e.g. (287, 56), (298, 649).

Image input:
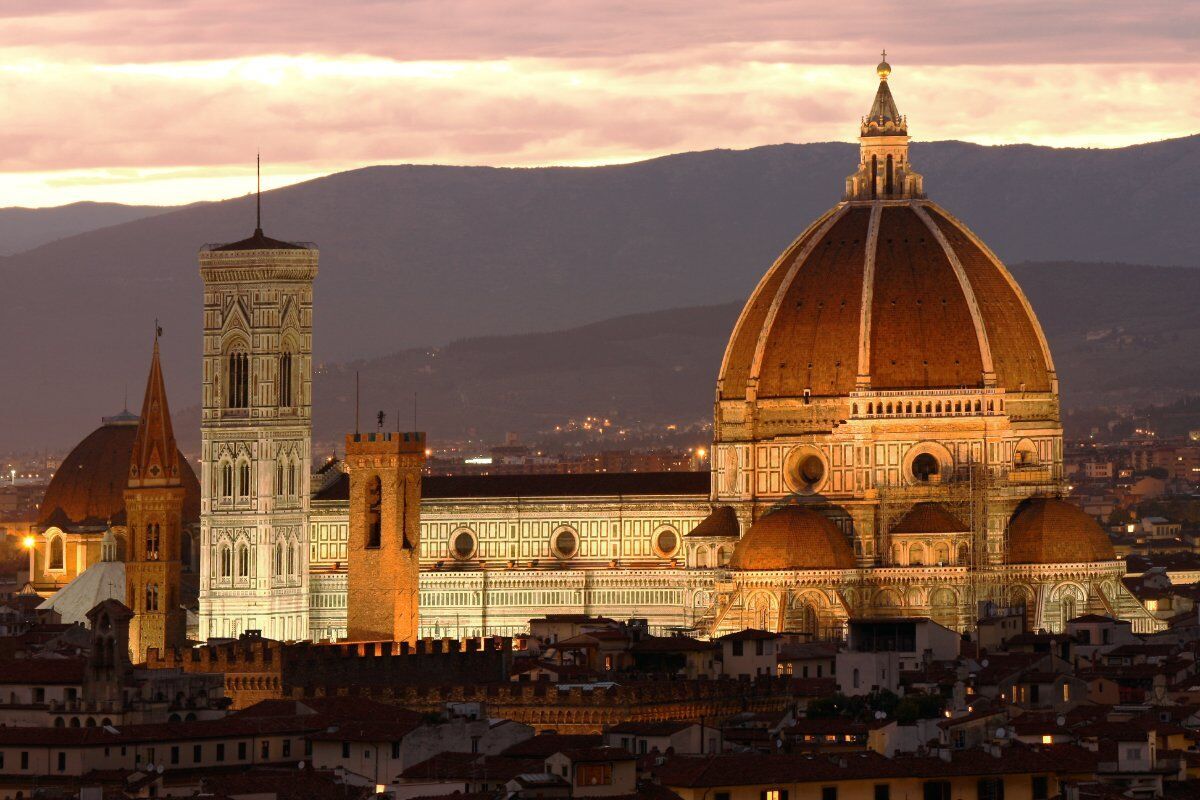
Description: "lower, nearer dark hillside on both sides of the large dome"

(169, 263), (1200, 445)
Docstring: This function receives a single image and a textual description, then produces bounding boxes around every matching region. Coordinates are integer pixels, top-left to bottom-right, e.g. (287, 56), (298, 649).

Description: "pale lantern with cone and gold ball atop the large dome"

(846, 50), (925, 200)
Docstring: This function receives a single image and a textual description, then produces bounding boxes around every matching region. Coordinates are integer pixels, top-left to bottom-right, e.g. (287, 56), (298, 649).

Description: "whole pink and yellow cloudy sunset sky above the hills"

(0, 0), (1200, 206)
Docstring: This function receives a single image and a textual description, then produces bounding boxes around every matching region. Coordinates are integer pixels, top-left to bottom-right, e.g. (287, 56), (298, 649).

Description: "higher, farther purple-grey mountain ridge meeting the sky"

(0, 137), (1200, 445)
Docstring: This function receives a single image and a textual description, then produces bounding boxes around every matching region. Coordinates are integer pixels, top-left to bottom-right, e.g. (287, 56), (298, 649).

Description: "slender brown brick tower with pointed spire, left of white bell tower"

(125, 326), (187, 662)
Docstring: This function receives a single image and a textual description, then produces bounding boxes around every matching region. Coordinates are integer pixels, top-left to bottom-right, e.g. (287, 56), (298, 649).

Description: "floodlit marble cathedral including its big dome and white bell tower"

(32, 64), (1147, 639)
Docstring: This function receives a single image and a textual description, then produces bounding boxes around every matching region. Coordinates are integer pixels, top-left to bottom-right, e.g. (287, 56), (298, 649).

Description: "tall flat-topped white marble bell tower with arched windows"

(199, 203), (318, 639)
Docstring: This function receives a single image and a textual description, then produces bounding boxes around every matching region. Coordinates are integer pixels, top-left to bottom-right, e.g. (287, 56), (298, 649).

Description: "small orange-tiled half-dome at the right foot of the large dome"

(1008, 498), (1117, 564)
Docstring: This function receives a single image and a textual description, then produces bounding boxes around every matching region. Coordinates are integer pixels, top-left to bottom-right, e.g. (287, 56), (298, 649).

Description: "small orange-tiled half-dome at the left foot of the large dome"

(730, 505), (858, 570)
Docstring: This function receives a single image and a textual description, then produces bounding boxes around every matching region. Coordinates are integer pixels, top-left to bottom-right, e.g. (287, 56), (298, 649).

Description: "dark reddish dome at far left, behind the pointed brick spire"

(37, 413), (200, 528)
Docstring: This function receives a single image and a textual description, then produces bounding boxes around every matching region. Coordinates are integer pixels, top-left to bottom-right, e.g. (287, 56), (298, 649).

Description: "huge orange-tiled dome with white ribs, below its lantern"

(719, 198), (1055, 399)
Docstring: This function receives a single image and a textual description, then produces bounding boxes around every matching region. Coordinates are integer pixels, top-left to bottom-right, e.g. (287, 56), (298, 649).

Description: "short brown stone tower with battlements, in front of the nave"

(346, 433), (425, 642)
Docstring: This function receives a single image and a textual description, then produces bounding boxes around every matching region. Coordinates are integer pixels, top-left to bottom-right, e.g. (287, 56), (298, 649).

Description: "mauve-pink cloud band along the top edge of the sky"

(0, 0), (1200, 64)
